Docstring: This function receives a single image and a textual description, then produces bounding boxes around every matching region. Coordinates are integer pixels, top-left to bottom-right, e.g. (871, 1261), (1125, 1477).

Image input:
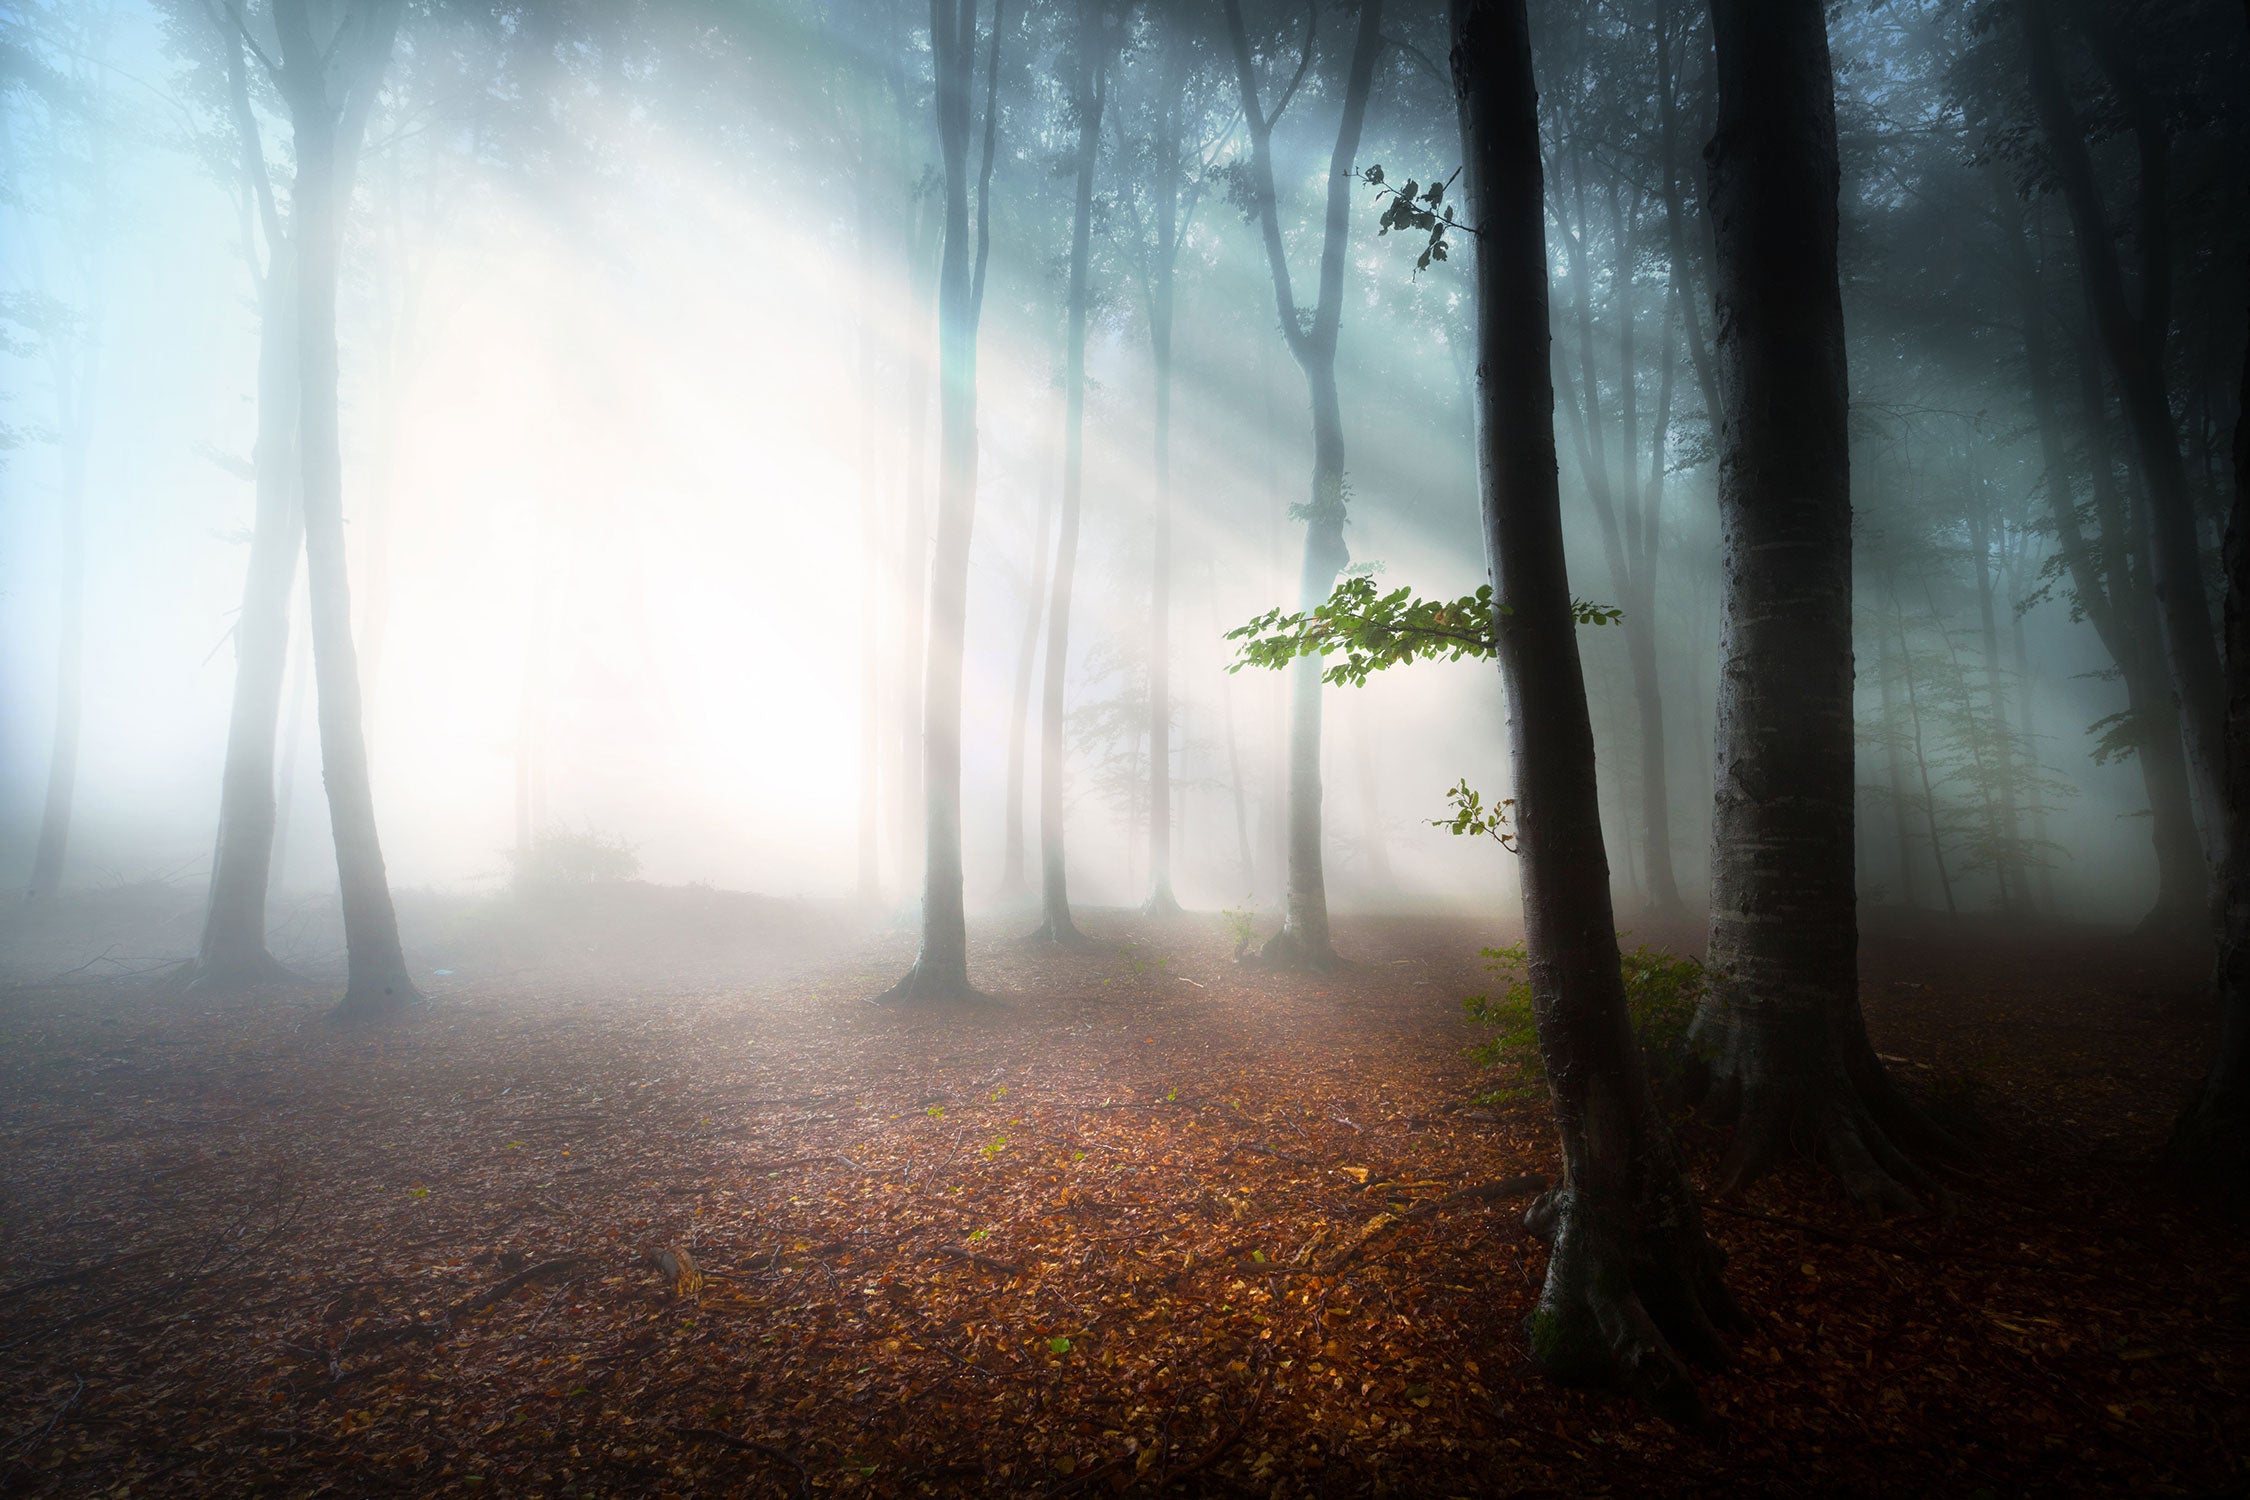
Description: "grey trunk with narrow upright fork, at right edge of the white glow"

(878, 0), (1006, 1001)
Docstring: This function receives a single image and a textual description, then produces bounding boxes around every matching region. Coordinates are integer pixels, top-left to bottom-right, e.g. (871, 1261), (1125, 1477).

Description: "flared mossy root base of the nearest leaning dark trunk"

(1523, 1183), (1744, 1426)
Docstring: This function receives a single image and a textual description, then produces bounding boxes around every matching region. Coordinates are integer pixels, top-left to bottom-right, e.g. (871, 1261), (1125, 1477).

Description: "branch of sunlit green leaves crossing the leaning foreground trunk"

(1226, 576), (1625, 688)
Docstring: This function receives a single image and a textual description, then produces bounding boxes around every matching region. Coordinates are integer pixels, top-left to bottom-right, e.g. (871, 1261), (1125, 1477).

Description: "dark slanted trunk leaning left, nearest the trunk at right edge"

(2016, 0), (2228, 864)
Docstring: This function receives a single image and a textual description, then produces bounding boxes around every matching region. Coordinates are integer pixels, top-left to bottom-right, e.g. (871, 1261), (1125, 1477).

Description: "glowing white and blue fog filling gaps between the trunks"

(0, 2), (2241, 940)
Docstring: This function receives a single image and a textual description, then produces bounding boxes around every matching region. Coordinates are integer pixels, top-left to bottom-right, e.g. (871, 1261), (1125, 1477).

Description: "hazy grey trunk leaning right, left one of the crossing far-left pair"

(187, 255), (304, 990)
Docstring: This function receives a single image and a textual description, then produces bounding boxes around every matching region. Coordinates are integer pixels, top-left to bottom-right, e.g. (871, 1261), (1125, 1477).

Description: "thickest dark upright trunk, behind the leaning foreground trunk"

(1697, 0), (1949, 1210)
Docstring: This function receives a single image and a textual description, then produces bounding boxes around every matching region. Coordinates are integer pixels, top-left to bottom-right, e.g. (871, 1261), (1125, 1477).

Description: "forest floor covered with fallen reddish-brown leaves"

(0, 888), (2250, 1498)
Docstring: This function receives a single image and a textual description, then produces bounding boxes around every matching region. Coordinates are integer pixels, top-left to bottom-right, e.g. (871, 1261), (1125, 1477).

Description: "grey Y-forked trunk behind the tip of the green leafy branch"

(1226, 0), (1384, 969)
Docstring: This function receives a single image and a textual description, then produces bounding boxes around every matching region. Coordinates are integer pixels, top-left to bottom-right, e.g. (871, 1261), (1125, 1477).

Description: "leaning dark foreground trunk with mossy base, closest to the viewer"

(1451, 0), (1737, 1419)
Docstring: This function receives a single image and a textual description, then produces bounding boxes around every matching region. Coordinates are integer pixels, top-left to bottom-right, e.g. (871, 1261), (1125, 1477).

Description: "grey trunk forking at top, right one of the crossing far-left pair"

(275, 0), (421, 1021)
